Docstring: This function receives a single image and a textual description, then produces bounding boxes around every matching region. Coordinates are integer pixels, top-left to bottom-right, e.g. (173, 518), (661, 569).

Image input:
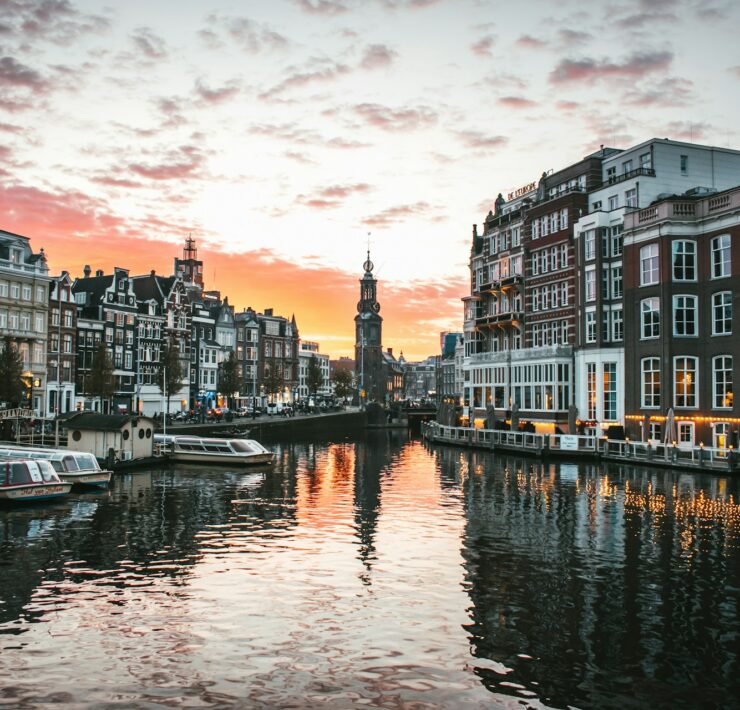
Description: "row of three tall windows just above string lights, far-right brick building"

(640, 355), (733, 409)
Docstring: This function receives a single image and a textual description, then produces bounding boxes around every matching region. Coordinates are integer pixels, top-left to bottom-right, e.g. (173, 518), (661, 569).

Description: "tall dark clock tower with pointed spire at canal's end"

(355, 249), (385, 403)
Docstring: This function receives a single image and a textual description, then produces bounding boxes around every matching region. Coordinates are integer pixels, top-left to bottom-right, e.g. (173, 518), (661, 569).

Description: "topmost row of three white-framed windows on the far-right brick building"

(640, 234), (732, 286)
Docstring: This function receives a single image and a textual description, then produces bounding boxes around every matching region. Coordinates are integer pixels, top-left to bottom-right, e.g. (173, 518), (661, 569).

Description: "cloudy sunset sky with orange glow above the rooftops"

(0, 0), (740, 358)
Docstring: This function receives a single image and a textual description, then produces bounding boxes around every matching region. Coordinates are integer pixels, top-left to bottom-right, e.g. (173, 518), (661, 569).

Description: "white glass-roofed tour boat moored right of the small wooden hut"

(154, 434), (274, 466)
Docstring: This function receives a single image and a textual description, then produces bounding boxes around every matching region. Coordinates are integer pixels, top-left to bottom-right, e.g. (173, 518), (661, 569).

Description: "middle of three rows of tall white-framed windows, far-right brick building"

(640, 291), (732, 340)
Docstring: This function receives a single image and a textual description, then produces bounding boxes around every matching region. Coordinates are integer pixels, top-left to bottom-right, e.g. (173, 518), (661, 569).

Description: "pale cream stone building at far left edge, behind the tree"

(0, 230), (49, 412)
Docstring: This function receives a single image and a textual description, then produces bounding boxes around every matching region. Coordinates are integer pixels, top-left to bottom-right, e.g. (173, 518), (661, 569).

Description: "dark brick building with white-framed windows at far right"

(624, 187), (740, 448)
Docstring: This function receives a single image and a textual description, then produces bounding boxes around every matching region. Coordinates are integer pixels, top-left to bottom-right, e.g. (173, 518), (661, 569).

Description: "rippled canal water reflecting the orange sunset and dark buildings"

(0, 432), (740, 710)
